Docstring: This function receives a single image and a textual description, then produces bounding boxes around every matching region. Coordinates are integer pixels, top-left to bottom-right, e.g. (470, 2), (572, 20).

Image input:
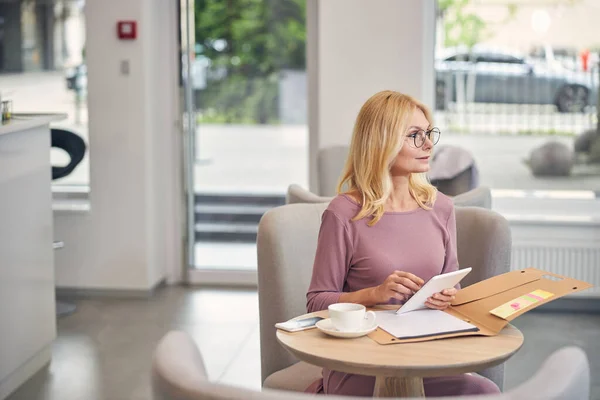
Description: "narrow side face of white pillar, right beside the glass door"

(144, 0), (186, 288)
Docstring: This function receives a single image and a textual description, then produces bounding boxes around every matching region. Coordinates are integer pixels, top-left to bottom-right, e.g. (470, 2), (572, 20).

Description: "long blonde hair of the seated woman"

(337, 90), (437, 226)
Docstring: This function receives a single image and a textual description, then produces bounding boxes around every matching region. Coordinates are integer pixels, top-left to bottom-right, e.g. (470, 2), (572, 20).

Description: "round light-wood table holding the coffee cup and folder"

(277, 311), (523, 397)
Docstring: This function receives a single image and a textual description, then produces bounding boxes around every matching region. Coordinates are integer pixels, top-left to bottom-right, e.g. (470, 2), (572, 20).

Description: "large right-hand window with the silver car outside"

(435, 0), (600, 191)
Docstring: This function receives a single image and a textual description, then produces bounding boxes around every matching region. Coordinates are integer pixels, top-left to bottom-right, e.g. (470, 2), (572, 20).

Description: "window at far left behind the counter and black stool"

(0, 0), (89, 186)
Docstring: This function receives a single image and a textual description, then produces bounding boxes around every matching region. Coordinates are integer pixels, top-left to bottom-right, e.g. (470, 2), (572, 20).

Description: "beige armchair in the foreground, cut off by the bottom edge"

(152, 331), (590, 400)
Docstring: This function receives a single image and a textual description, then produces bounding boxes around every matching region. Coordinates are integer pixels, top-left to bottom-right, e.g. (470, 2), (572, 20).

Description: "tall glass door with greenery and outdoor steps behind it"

(181, 0), (308, 284)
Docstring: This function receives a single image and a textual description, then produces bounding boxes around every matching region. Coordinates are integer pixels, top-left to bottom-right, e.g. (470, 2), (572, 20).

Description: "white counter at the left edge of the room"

(0, 115), (64, 399)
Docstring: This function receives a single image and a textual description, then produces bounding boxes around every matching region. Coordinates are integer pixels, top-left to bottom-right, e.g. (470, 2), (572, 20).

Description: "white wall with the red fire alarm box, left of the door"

(55, 0), (183, 290)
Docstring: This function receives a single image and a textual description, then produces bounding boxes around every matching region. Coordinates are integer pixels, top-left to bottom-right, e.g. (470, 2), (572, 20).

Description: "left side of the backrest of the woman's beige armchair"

(256, 203), (328, 381)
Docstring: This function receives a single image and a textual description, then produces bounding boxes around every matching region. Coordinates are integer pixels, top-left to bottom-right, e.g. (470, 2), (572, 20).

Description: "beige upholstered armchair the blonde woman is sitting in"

(257, 203), (511, 390)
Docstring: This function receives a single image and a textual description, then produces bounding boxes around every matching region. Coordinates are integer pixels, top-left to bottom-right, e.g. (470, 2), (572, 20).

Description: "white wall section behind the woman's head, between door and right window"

(307, 0), (435, 191)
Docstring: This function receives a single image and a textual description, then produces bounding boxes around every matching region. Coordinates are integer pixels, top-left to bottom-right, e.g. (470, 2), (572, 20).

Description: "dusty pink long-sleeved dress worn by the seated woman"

(306, 192), (500, 397)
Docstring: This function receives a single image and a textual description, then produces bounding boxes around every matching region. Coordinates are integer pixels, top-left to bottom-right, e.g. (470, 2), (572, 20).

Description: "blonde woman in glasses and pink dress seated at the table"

(306, 91), (499, 396)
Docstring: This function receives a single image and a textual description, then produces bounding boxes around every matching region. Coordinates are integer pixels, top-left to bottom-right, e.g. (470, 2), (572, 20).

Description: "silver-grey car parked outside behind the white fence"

(435, 47), (599, 112)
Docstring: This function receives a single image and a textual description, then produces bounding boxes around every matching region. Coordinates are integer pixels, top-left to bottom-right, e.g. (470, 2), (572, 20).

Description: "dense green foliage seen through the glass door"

(195, 0), (306, 124)
